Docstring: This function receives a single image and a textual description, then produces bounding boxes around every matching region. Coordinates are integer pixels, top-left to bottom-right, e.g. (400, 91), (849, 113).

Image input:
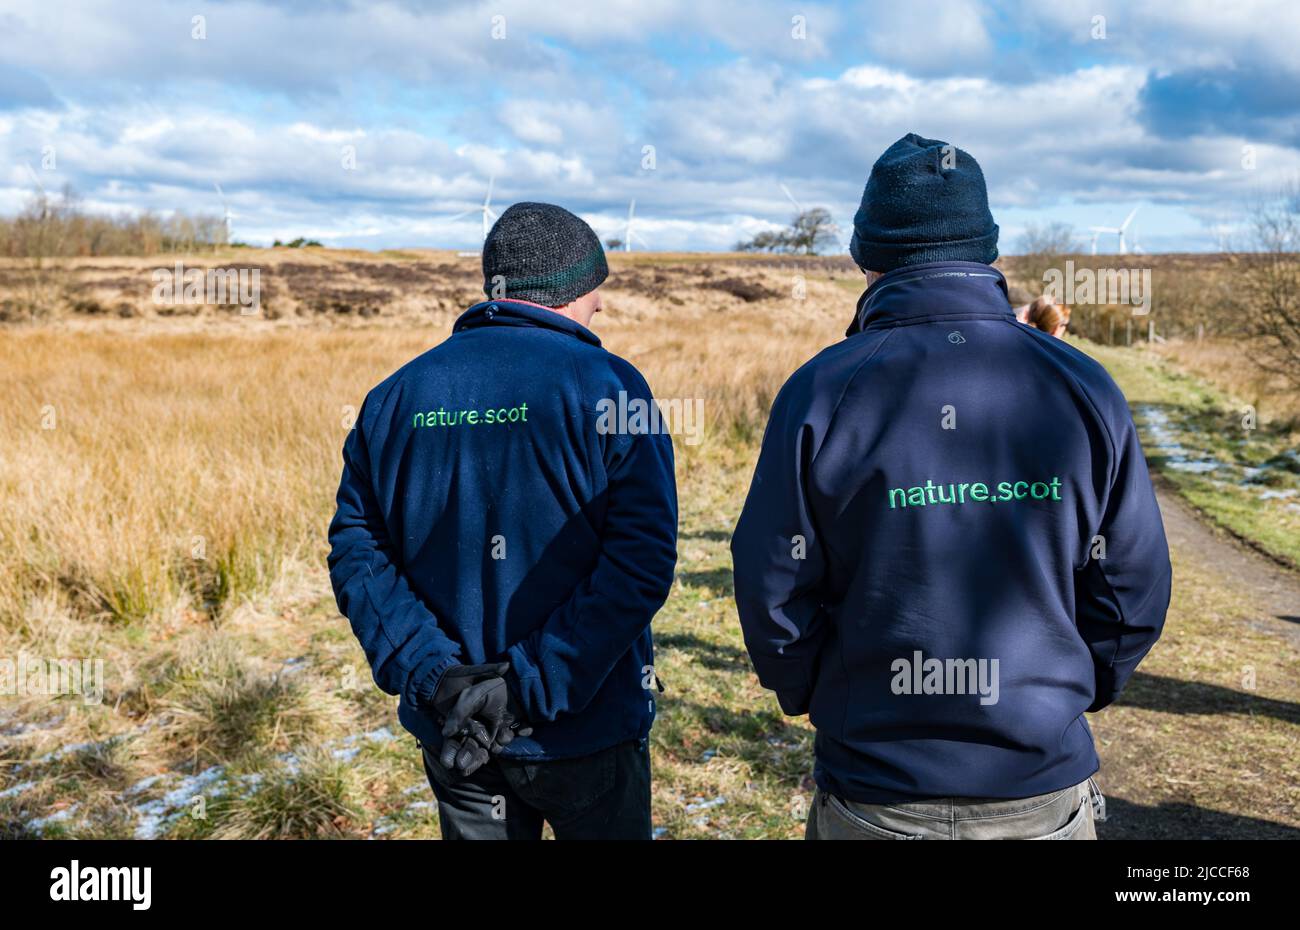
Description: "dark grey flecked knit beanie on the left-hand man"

(484, 203), (610, 307)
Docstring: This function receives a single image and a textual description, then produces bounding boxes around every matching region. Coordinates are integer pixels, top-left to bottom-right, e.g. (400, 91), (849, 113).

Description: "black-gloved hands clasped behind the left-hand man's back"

(433, 662), (533, 775)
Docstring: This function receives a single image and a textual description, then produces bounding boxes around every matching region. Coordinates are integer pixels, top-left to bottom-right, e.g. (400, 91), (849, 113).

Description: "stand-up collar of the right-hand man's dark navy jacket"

(844, 261), (1015, 336)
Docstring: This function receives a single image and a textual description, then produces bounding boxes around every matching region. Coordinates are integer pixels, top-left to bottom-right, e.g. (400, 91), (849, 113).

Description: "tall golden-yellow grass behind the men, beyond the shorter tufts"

(0, 291), (833, 628)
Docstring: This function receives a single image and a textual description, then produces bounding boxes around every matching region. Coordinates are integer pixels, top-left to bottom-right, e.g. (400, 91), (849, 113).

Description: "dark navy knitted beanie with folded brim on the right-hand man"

(849, 133), (997, 272)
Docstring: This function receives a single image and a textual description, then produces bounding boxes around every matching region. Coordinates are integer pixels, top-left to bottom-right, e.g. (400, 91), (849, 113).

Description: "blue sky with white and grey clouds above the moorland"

(0, 0), (1300, 251)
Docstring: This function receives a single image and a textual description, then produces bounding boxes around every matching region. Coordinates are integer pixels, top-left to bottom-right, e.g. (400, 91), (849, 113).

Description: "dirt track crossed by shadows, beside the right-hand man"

(1089, 485), (1300, 839)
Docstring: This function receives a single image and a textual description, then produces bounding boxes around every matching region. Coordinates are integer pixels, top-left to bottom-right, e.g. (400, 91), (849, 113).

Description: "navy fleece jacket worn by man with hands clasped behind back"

(329, 300), (677, 758)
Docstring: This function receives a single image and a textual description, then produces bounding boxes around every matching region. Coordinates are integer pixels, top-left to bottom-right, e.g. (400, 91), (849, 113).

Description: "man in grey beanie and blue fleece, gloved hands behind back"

(329, 203), (677, 839)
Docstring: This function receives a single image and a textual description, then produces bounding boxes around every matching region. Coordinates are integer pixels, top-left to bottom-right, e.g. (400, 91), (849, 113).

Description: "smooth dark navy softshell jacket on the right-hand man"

(732, 261), (1170, 804)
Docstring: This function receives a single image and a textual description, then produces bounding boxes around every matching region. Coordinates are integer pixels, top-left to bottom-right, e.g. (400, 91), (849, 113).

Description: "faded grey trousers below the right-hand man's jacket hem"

(803, 778), (1106, 839)
